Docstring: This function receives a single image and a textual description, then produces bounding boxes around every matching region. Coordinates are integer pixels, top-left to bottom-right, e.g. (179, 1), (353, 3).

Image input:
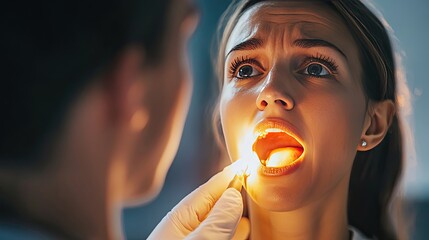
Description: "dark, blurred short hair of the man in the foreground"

(0, 0), (170, 167)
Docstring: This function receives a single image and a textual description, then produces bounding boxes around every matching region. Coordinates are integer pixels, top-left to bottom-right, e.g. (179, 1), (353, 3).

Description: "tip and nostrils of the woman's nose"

(256, 84), (295, 111)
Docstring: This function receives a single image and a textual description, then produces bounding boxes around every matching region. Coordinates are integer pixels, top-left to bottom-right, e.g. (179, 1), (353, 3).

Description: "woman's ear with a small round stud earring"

(358, 100), (396, 151)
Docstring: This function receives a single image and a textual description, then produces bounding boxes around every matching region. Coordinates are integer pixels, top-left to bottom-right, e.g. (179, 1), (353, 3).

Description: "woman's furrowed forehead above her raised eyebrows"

(225, 1), (354, 55)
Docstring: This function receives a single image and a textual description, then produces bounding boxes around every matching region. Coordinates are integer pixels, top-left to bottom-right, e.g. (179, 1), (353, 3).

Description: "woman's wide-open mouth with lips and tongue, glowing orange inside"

(252, 128), (304, 168)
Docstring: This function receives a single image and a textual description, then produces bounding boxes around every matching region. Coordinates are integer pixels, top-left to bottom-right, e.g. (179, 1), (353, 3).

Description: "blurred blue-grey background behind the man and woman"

(123, 0), (429, 240)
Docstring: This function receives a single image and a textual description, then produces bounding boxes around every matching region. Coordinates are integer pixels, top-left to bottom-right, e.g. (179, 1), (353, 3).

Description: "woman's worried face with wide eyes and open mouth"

(220, 1), (366, 211)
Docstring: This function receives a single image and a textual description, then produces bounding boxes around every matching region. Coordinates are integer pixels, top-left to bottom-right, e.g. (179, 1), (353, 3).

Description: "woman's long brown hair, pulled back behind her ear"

(213, 0), (409, 239)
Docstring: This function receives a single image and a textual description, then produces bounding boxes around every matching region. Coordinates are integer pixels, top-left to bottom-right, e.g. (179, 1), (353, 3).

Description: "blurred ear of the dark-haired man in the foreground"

(105, 47), (145, 124)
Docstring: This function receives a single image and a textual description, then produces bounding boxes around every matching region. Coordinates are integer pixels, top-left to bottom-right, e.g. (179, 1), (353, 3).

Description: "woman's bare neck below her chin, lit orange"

(247, 177), (349, 240)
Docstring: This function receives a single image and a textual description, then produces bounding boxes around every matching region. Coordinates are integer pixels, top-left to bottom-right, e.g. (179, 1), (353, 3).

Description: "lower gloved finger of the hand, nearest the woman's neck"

(186, 188), (243, 240)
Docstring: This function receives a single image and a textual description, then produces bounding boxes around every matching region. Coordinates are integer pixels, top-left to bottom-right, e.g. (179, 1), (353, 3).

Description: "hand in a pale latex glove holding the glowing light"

(148, 162), (243, 240)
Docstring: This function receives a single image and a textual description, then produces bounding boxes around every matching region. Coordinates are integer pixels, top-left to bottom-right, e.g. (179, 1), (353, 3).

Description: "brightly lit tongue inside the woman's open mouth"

(266, 147), (302, 167)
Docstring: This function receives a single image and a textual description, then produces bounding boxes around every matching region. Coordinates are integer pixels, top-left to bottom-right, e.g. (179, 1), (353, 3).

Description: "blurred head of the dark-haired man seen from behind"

(0, 0), (195, 202)
